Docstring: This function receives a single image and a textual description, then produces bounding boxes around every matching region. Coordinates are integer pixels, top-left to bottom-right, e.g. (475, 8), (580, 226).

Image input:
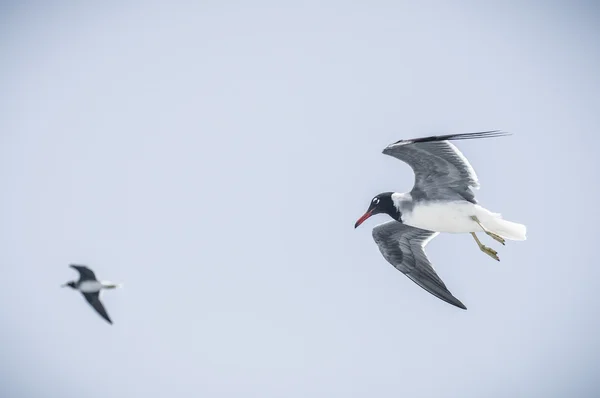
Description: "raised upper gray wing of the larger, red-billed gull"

(383, 130), (508, 203)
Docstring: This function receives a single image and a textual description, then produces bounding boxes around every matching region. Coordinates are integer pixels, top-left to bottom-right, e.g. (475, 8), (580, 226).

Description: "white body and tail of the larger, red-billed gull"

(402, 201), (526, 240)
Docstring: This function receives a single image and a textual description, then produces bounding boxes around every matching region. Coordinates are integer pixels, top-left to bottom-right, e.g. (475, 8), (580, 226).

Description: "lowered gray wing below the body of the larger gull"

(373, 220), (467, 310)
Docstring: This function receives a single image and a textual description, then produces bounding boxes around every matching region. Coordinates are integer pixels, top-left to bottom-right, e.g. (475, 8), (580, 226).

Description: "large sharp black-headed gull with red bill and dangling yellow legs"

(354, 130), (526, 310)
